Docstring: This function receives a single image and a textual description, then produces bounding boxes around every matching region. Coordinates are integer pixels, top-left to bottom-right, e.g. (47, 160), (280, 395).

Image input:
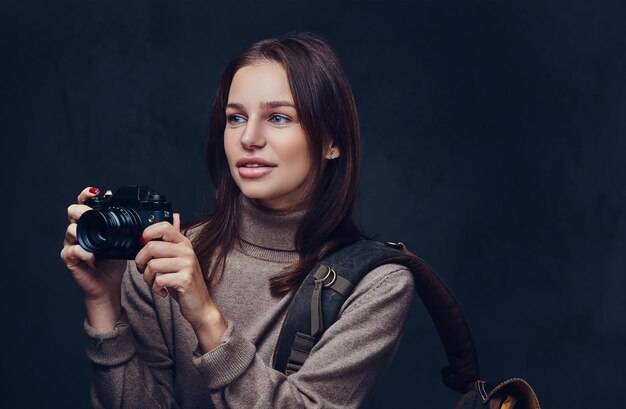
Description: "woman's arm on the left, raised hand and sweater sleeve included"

(61, 188), (172, 408)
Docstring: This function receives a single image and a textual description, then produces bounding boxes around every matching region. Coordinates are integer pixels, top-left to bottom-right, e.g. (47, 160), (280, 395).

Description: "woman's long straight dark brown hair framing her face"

(192, 33), (362, 296)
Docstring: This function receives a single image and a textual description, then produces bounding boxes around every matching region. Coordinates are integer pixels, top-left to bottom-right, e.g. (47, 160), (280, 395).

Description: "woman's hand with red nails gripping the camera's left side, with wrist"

(61, 188), (126, 332)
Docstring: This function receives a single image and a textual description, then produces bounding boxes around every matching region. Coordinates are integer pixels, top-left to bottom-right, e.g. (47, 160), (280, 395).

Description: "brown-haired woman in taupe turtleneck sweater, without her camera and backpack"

(61, 34), (414, 408)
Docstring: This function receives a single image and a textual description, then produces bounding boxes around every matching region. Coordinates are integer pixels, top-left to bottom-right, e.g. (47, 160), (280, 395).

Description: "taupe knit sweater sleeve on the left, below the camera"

(84, 262), (178, 408)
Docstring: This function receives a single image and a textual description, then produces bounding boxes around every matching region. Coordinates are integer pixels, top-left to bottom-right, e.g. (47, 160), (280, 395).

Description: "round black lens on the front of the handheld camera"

(76, 207), (142, 258)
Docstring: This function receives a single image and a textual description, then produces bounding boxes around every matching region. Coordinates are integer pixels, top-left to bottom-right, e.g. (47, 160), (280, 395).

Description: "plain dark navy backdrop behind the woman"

(0, 0), (626, 408)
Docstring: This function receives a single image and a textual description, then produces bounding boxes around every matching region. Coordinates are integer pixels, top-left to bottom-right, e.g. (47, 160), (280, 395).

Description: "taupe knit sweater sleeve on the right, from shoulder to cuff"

(194, 264), (414, 408)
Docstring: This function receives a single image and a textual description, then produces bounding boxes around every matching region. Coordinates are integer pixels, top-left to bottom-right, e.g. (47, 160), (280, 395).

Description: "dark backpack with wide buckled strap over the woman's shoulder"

(273, 240), (540, 409)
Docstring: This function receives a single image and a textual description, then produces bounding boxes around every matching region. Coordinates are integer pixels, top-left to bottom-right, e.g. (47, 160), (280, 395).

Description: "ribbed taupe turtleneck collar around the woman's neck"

(239, 195), (305, 262)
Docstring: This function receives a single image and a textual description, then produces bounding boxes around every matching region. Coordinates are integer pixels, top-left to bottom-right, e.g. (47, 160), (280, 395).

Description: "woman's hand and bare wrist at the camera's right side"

(135, 213), (227, 352)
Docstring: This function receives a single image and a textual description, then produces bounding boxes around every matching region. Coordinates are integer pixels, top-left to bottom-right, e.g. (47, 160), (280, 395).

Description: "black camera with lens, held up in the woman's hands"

(76, 186), (174, 260)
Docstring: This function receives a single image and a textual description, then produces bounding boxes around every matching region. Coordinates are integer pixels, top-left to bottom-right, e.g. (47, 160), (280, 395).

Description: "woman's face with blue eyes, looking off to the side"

(224, 61), (311, 210)
